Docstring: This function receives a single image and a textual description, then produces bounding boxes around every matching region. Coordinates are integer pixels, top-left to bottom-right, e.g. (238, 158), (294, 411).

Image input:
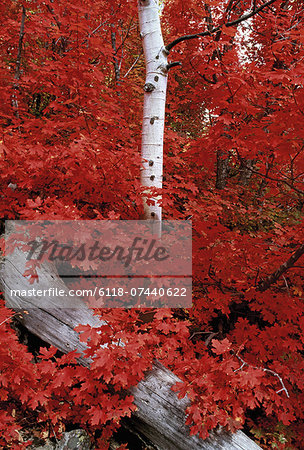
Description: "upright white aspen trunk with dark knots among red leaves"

(138, 0), (168, 223)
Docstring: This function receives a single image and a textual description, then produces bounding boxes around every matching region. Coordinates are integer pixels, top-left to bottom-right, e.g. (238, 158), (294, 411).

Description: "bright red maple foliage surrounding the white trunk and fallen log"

(0, 0), (304, 448)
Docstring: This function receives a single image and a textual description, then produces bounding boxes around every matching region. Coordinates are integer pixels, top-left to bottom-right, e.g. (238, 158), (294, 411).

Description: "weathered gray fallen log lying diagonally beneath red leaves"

(0, 249), (260, 450)
